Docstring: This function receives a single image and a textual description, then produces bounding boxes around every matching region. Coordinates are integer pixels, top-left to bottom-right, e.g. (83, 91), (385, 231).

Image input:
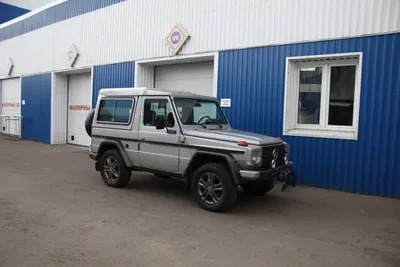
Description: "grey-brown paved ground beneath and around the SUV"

(0, 140), (400, 267)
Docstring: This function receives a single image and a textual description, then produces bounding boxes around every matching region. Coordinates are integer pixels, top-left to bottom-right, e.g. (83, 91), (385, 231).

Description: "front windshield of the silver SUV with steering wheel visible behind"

(174, 98), (228, 125)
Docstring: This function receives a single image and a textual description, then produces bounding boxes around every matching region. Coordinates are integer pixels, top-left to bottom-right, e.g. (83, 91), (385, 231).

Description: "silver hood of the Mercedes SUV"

(185, 129), (282, 145)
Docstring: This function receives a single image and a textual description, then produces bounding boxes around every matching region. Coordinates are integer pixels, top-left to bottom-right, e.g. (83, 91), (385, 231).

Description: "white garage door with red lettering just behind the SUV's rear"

(68, 73), (92, 146)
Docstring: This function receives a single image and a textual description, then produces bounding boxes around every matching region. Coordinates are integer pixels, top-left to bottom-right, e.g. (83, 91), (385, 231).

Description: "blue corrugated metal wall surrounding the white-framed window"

(218, 34), (400, 198)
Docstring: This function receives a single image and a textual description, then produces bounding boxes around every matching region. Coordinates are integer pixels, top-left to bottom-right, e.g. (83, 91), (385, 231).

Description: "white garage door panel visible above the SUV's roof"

(154, 62), (214, 96)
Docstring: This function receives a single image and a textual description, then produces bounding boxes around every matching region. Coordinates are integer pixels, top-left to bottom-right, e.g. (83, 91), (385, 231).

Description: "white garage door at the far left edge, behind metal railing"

(1, 78), (21, 135)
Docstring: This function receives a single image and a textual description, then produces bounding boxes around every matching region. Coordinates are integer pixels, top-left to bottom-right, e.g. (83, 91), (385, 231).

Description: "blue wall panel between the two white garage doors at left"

(21, 73), (51, 143)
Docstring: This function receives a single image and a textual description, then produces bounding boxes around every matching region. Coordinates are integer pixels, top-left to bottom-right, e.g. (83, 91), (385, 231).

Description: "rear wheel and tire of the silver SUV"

(100, 149), (131, 188)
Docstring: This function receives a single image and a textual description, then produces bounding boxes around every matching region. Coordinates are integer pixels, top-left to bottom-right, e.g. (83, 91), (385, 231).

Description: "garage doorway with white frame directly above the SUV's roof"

(135, 53), (218, 97)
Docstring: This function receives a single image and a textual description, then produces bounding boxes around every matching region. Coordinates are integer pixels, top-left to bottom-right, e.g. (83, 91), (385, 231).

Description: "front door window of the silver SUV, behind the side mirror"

(143, 99), (175, 127)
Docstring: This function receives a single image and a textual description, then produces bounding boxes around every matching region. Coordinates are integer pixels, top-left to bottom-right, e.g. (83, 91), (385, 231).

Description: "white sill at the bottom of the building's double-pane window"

(283, 129), (357, 140)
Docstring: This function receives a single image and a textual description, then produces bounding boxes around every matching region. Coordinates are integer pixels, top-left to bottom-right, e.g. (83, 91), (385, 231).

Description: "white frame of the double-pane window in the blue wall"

(283, 52), (362, 140)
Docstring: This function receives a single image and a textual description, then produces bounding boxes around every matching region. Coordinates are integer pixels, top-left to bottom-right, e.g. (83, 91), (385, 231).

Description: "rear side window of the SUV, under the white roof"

(97, 99), (134, 124)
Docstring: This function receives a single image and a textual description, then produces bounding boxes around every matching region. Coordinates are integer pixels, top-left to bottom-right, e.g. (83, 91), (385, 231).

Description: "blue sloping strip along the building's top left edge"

(0, 0), (125, 41)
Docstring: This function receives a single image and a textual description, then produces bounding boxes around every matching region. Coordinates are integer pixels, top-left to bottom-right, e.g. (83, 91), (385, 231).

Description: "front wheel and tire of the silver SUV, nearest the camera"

(191, 163), (237, 212)
